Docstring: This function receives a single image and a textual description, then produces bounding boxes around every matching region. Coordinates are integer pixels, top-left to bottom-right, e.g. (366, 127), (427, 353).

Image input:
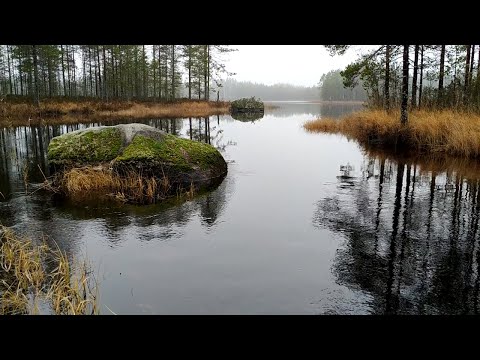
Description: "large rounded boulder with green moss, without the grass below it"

(48, 124), (227, 186)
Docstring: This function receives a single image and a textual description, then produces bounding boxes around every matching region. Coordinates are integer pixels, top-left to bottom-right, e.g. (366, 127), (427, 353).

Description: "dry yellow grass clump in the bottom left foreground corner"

(0, 225), (98, 315)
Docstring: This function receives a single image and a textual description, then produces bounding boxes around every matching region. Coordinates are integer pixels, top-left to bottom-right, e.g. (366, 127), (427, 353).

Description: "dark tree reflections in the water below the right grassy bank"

(314, 153), (480, 314)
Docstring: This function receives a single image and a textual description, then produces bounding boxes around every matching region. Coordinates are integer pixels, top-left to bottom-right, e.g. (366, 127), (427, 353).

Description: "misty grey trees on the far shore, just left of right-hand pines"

(318, 70), (368, 101)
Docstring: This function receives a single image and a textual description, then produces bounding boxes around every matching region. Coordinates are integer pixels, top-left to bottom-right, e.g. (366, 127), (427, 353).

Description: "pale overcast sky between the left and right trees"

(225, 45), (374, 86)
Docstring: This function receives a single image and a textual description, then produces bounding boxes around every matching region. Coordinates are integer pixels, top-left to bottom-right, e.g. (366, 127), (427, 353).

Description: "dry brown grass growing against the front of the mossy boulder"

(53, 166), (195, 204)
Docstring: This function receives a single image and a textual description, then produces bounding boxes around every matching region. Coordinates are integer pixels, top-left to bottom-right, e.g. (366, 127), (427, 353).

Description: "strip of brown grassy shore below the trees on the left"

(0, 99), (230, 127)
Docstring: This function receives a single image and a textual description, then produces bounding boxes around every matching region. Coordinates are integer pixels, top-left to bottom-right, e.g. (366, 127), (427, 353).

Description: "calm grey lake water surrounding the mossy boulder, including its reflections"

(0, 102), (480, 314)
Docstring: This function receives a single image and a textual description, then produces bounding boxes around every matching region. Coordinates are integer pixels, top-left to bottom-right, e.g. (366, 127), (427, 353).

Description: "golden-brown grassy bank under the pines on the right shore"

(304, 110), (480, 158)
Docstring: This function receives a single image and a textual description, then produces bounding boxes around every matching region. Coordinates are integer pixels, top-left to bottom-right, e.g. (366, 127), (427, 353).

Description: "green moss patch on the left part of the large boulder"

(48, 128), (122, 164)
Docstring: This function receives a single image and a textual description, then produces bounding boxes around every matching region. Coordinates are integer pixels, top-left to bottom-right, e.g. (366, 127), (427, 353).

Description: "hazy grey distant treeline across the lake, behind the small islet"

(220, 78), (320, 101)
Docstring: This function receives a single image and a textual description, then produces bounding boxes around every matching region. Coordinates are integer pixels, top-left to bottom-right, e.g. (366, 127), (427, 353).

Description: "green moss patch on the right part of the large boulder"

(116, 134), (223, 171)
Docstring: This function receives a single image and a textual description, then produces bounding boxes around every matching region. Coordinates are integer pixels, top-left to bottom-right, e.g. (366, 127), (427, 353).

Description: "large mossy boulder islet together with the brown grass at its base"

(48, 123), (227, 203)
